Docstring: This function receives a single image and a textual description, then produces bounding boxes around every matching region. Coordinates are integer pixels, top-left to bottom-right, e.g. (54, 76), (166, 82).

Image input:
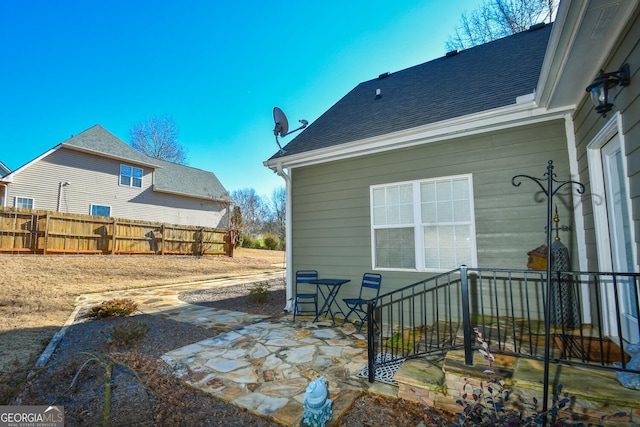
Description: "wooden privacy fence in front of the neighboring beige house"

(0, 207), (233, 256)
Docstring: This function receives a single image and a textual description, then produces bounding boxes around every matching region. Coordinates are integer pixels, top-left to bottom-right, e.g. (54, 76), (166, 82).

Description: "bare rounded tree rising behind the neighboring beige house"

(129, 116), (188, 165)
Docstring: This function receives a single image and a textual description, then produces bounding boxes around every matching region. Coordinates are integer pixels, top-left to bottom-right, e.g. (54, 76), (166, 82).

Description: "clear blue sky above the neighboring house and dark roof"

(0, 0), (482, 197)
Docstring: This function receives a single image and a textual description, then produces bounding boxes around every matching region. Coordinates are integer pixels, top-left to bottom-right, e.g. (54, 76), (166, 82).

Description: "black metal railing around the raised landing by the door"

(368, 266), (640, 386)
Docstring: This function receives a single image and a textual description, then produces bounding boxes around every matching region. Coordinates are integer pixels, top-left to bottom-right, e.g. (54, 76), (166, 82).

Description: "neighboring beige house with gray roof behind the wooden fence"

(0, 125), (231, 228)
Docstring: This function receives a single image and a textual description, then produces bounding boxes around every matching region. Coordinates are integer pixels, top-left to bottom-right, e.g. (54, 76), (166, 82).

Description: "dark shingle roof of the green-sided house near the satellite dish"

(272, 25), (552, 159)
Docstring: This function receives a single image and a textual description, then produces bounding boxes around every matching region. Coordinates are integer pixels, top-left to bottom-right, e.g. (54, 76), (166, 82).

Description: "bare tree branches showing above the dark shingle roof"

(446, 0), (557, 51)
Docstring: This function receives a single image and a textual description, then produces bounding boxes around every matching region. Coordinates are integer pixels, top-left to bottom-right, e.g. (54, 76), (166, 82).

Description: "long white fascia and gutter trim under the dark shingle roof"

(263, 102), (575, 170)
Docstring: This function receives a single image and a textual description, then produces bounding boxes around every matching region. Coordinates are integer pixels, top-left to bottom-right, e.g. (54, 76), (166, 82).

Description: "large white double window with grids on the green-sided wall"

(371, 175), (476, 271)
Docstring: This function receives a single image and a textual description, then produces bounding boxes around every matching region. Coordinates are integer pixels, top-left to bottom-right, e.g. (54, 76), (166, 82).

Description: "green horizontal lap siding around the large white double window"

(291, 120), (575, 298)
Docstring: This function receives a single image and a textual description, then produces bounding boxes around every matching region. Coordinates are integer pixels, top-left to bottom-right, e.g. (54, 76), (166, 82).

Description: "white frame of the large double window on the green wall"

(369, 174), (478, 272)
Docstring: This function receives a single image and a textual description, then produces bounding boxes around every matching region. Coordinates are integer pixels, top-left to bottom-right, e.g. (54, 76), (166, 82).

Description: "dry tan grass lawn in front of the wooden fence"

(0, 249), (284, 382)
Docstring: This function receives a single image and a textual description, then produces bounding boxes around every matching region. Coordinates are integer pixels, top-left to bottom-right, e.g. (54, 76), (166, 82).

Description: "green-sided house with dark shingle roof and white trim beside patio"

(264, 0), (640, 342)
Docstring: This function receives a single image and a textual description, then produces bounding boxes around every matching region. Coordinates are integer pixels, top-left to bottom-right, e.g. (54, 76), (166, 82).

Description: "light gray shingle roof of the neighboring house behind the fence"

(61, 125), (231, 202)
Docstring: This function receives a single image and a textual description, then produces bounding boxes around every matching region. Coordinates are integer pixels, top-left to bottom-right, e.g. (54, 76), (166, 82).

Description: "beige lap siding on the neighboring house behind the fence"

(8, 148), (228, 228)
